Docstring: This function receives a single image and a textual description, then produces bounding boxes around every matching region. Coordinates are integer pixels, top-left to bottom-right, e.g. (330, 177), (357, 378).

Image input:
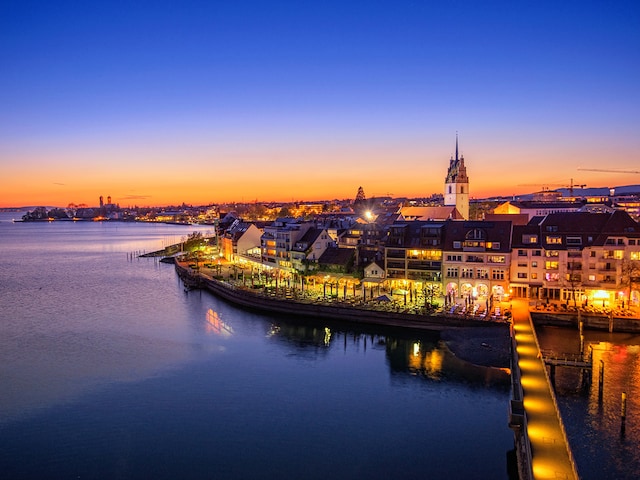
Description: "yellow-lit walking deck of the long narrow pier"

(512, 300), (578, 480)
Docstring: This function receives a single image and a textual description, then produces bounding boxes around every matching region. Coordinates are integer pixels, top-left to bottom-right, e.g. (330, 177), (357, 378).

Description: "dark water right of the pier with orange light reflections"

(537, 327), (640, 480)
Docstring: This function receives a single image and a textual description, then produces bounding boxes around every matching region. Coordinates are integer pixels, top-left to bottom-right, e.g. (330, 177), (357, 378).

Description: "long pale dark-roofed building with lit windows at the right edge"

(510, 210), (640, 308)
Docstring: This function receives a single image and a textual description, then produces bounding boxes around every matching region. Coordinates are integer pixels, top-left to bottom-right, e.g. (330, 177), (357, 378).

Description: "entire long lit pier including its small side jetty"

(509, 300), (588, 480)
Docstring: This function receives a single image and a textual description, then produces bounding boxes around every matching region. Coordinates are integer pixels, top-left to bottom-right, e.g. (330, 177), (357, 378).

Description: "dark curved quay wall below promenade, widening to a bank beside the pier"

(175, 262), (509, 368)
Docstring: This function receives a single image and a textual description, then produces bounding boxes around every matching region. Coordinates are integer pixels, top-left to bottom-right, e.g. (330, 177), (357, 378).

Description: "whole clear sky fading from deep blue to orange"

(0, 0), (640, 207)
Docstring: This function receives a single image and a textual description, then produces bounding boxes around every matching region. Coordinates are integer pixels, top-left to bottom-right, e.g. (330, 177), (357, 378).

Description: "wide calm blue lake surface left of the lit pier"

(0, 214), (513, 479)
